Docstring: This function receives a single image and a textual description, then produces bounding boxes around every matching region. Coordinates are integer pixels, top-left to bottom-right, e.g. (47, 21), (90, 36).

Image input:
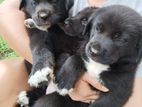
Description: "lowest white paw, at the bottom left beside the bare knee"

(17, 91), (29, 107)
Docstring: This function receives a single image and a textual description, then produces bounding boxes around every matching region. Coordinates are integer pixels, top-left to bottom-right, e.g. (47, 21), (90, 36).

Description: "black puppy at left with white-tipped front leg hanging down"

(20, 0), (73, 87)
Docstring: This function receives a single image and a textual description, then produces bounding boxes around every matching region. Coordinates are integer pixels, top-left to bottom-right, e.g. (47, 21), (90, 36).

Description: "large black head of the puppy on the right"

(86, 5), (142, 64)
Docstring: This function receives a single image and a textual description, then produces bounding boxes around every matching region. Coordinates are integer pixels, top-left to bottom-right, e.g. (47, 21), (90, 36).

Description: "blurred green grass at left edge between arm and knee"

(0, 0), (18, 59)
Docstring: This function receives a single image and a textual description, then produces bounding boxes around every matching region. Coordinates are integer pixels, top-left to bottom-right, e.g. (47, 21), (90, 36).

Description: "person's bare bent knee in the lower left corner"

(0, 58), (30, 107)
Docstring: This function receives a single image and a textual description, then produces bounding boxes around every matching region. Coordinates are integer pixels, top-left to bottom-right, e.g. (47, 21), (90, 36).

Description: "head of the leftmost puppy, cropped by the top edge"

(19, 0), (73, 28)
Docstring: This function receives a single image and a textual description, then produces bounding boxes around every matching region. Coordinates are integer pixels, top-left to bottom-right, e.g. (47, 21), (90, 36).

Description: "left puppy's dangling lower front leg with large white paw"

(28, 49), (53, 87)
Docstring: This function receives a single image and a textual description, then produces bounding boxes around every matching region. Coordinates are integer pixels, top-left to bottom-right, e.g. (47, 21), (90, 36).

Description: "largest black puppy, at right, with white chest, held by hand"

(32, 5), (142, 107)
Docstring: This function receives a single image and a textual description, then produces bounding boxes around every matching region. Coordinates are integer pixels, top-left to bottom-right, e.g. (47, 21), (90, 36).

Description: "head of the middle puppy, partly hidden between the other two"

(63, 7), (97, 37)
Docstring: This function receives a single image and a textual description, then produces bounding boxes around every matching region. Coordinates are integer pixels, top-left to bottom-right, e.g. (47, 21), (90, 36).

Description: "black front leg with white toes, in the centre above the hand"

(55, 55), (85, 96)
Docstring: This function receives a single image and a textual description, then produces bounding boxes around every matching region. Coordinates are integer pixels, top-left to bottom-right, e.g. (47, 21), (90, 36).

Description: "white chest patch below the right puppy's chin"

(85, 58), (109, 80)
